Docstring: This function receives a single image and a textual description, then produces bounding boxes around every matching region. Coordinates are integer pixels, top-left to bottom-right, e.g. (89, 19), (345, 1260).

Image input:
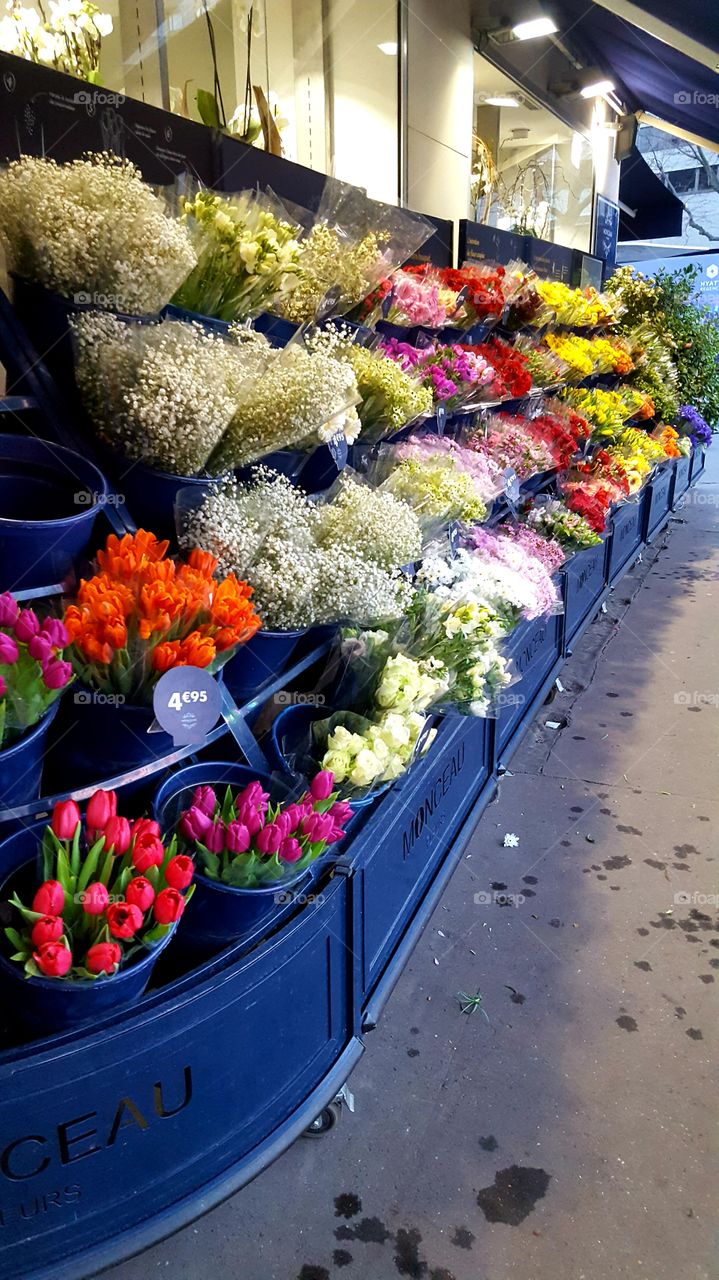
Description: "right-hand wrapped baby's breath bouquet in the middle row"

(207, 332), (362, 474)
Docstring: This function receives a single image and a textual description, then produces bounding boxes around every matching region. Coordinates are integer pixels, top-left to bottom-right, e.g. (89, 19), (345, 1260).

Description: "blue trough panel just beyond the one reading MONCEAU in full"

(495, 614), (563, 759)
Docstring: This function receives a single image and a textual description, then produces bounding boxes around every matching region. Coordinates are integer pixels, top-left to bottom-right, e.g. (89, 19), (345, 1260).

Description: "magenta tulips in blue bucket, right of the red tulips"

(166, 771), (352, 950)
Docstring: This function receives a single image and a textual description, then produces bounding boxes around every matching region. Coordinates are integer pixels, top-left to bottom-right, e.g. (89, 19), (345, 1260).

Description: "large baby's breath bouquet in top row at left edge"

(0, 152), (196, 315)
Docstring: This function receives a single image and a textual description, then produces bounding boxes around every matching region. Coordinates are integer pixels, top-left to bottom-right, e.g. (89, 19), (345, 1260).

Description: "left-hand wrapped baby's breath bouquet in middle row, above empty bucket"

(70, 312), (274, 476)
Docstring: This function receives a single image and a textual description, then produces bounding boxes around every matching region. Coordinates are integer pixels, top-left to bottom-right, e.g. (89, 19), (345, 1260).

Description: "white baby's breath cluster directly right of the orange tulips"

(178, 467), (421, 631)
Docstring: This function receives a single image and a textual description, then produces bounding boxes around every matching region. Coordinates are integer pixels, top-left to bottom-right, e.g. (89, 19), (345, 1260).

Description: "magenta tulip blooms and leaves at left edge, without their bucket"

(0, 591), (73, 747)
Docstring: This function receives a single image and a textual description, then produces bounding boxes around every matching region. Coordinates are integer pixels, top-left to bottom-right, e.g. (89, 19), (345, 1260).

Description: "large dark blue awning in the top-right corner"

(553, 0), (719, 146)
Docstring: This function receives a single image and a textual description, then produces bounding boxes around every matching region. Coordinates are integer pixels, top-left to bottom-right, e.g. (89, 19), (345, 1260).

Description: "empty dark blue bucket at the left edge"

(0, 435), (107, 591)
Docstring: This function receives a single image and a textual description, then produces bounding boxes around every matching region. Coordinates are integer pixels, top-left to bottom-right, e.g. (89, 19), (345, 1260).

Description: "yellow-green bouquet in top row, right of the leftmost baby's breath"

(173, 191), (299, 320)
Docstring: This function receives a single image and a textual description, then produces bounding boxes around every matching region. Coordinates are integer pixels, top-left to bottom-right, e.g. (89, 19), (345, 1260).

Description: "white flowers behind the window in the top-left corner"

(0, 0), (113, 84)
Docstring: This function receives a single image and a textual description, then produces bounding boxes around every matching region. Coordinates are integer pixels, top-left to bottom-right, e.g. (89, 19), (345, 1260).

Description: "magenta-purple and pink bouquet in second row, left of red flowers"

(381, 338), (502, 411)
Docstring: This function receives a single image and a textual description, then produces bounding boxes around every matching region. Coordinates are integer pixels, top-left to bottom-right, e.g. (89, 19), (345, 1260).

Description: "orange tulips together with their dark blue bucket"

(54, 529), (260, 788)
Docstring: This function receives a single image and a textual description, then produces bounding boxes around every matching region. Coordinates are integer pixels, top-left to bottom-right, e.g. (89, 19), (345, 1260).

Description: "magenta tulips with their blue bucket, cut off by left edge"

(0, 591), (73, 809)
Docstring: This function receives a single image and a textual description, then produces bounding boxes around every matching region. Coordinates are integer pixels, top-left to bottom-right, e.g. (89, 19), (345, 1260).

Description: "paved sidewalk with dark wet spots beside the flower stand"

(109, 458), (719, 1280)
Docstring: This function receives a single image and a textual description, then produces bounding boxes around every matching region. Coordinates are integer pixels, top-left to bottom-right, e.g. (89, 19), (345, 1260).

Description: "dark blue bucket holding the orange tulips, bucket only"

(46, 684), (173, 791)
